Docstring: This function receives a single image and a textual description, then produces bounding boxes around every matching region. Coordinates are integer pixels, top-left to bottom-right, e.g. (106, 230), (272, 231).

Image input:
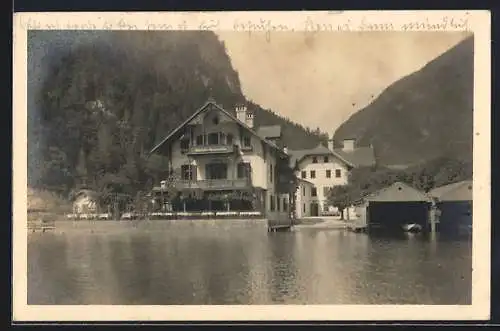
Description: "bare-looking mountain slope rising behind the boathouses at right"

(334, 37), (474, 169)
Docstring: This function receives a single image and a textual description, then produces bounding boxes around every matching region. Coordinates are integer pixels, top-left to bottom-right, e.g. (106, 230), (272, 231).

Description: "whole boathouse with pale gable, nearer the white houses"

(355, 182), (432, 228)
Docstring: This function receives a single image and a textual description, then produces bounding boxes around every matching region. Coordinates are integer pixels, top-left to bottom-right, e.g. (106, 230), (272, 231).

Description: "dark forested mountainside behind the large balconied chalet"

(28, 31), (325, 194)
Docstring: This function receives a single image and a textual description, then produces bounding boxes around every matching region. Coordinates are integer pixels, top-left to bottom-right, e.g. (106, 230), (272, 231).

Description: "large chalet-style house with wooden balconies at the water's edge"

(151, 100), (293, 222)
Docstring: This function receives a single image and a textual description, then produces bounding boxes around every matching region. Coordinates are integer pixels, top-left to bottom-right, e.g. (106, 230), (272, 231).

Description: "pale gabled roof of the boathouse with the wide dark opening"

(357, 182), (431, 203)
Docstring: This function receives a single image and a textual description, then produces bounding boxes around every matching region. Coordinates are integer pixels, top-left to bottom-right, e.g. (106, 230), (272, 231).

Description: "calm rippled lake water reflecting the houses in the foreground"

(28, 221), (472, 305)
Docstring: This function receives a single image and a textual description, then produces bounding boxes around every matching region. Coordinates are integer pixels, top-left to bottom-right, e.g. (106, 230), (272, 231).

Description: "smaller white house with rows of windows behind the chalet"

(289, 139), (375, 218)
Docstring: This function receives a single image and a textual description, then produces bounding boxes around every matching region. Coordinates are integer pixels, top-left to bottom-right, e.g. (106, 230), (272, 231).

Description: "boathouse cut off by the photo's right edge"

(429, 180), (472, 232)
